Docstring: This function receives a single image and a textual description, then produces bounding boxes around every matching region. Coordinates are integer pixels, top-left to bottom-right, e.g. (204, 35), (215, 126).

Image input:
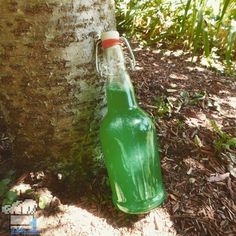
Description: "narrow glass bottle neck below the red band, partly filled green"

(104, 45), (137, 112)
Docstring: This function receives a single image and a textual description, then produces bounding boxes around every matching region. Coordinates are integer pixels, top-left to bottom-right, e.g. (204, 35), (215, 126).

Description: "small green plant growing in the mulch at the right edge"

(210, 120), (236, 152)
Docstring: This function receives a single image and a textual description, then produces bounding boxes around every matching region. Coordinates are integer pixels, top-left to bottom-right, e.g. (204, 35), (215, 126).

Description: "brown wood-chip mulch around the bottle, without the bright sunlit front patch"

(0, 48), (236, 236)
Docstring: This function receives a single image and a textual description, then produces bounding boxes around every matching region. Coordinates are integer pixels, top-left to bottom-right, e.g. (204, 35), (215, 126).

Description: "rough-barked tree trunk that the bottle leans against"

(0, 0), (115, 173)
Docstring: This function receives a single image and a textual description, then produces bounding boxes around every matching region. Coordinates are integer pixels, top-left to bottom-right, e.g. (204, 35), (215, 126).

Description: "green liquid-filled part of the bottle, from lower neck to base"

(100, 85), (165, 214)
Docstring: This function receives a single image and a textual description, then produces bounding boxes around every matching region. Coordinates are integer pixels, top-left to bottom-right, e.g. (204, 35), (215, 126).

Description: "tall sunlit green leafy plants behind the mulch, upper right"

(116, 0), (236, 69)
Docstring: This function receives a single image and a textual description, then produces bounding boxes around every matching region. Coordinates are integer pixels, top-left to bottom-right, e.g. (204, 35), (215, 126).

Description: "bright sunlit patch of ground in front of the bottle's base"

(37, 191), (176, 236)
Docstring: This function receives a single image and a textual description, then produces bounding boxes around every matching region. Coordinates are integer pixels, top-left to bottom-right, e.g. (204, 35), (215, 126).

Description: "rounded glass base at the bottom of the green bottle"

(113, 190), (166, 214)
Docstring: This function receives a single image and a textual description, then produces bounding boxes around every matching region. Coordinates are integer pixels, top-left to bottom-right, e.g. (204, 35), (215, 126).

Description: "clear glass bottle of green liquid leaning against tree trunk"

(100, 31), (165, 214)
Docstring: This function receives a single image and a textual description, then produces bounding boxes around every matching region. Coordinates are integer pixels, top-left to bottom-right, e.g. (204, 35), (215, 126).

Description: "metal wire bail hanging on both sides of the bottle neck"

(95, 37), (136, 76)
